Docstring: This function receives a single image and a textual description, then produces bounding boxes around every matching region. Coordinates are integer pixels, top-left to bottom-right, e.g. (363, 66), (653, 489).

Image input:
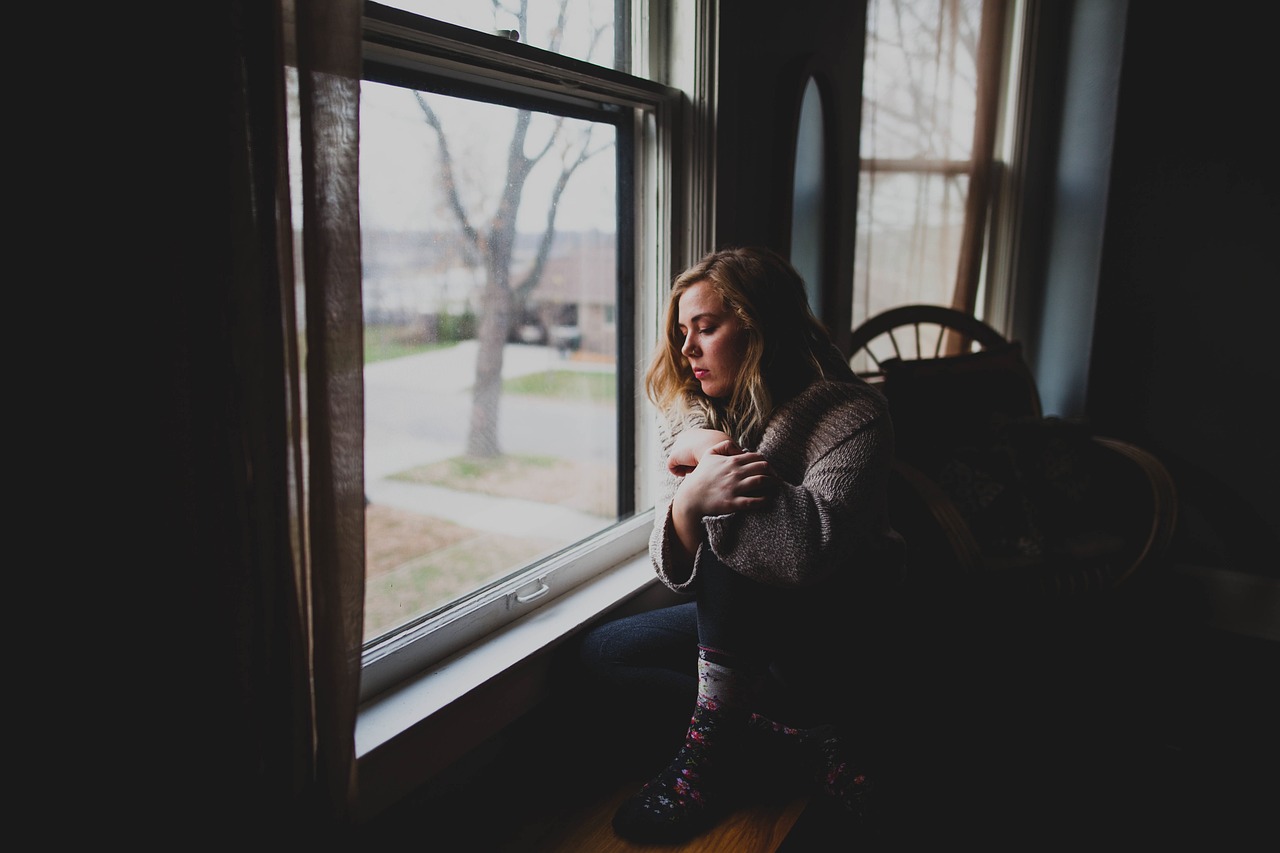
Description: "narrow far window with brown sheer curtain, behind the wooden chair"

(854, 0), (1021, 356)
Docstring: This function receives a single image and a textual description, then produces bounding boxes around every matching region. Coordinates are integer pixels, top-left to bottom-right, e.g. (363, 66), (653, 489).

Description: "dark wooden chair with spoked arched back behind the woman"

(850, 305), (1178, 599)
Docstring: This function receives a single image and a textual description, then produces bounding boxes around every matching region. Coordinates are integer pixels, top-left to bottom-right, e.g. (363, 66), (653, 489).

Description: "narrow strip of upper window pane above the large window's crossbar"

(385, 0), (627, 70)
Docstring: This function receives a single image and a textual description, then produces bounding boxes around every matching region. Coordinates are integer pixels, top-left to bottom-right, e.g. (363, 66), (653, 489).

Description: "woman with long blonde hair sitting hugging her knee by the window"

(582, 248), (901, 843)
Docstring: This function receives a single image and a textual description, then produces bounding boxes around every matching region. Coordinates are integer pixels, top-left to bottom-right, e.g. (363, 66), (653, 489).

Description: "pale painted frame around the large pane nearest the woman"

(361, 4), (703, 702)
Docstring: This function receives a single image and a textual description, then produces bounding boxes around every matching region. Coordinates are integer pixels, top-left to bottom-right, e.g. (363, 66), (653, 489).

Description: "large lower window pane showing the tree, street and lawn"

(360, 81), (621, 642)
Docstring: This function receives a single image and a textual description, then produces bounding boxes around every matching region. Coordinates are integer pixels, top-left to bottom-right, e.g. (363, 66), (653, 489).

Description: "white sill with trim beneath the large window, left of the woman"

(356, 551), (671, 820)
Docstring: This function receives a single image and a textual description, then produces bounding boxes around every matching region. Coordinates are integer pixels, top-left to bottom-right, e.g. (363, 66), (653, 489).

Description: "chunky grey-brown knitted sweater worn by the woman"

(649, 379), (901, 593)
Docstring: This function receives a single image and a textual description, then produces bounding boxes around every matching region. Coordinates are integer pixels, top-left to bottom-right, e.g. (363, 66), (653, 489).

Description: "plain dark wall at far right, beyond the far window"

(1088, 0), (1280, 576)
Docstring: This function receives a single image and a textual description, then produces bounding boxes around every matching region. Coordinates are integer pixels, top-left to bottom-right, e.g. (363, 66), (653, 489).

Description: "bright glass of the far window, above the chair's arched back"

(854, 0), (982, 356)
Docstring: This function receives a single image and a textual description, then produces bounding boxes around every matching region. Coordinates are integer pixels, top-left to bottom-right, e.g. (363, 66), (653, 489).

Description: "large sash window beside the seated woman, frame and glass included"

(360, 0), (678, 697)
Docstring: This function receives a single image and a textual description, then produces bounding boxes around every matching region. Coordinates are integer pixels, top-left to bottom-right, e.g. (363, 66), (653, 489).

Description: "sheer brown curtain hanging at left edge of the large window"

(296, 0), (365, 817)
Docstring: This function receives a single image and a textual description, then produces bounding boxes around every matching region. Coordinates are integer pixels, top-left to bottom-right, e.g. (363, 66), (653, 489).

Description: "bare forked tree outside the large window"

(415, 0), (612, 457)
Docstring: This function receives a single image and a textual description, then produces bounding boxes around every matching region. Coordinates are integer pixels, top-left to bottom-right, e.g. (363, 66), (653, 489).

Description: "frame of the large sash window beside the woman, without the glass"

(361, 3), (686, 702)
